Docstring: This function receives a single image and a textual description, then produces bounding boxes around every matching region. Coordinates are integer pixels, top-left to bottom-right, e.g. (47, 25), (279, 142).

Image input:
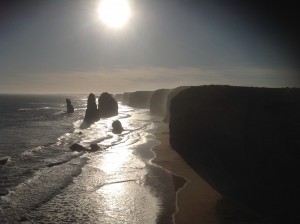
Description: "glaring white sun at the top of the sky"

(98, 0), (131, 29)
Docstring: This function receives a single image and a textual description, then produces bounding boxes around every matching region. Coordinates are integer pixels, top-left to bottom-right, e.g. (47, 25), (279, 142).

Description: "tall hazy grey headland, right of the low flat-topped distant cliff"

(150, 89), (171, 116)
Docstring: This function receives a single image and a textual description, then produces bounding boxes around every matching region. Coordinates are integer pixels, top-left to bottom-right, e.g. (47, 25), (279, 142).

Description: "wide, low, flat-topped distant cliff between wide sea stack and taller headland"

(128, 91), (153, 109)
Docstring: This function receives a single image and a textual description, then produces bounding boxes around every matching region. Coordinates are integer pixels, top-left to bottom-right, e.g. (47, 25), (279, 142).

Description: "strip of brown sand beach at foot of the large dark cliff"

(152, 123), (221, 224)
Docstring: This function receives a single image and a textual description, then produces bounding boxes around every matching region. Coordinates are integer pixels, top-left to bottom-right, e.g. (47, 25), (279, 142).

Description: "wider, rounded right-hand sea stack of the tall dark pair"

(98, 92), (118, 118)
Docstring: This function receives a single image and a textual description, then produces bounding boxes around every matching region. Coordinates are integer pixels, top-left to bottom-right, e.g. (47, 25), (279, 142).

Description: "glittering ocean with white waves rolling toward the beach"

(0, 95), (176, 224)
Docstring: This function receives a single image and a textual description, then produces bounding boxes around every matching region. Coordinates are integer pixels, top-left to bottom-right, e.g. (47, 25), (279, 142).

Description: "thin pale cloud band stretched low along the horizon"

(0, 67), (300, 94)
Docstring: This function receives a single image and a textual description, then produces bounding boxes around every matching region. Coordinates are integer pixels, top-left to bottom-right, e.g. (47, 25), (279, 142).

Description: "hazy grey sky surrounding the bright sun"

(0, 0), (300, 94)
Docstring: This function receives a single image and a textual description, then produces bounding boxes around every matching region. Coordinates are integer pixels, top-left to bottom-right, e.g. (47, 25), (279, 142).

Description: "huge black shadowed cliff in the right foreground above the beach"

(169, 86), (300, 217)
